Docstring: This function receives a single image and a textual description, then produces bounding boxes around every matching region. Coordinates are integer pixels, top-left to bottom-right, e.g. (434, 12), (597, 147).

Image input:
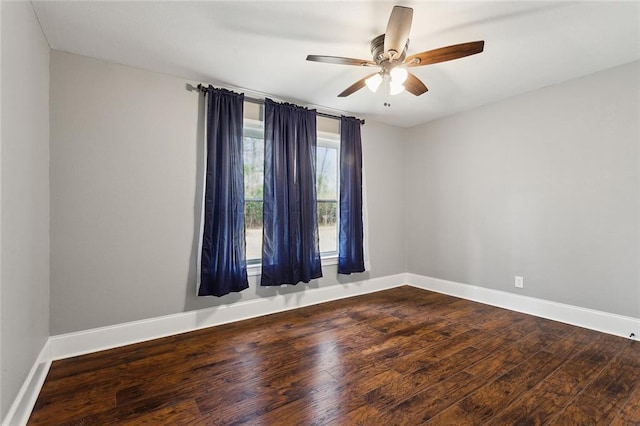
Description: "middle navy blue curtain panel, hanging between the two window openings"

(260, 99), (322, 286)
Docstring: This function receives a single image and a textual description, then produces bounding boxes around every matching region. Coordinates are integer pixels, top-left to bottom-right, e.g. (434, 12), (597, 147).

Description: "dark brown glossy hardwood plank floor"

(29, 287), (640, 425)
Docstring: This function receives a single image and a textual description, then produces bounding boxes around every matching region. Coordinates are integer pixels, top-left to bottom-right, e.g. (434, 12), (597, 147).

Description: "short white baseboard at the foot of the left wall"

(2, 339), (51, 426)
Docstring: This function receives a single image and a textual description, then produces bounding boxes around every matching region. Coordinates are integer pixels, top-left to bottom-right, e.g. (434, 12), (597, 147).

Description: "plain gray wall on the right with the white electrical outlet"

(405, 62), (640, 317)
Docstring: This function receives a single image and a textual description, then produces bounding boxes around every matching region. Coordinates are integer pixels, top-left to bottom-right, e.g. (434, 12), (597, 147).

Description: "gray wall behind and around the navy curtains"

(51, 50), (405, 335)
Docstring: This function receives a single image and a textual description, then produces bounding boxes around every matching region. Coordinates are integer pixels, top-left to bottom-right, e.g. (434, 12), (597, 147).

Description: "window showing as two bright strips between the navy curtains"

(243, 101), (340, 265)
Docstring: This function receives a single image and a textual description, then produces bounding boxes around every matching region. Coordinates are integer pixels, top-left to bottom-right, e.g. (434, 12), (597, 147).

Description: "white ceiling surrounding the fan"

(33, 1), (640, 127)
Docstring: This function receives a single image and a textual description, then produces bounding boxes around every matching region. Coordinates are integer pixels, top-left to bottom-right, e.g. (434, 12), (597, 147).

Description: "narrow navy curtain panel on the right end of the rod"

(338, 116), (365, 274)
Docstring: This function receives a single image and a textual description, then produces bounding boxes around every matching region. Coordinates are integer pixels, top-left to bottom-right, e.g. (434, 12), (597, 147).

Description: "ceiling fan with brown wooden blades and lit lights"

(307, 6), (484, 106)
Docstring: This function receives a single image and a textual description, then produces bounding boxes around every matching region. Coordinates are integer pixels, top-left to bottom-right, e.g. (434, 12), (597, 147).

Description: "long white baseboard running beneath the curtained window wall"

(50, 274), (405, 360)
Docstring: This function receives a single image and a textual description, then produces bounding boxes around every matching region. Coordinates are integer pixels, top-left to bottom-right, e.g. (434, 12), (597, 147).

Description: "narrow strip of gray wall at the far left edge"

(0, 2), (49, 419)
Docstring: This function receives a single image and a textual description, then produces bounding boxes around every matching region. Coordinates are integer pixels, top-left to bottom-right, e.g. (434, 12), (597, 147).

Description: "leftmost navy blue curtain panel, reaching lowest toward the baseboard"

(198, 86), (249, 296)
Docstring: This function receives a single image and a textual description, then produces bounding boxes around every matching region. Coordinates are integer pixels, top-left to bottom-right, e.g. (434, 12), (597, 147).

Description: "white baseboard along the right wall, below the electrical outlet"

(405, 274), (640, 339)
